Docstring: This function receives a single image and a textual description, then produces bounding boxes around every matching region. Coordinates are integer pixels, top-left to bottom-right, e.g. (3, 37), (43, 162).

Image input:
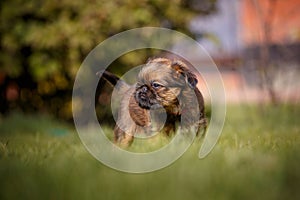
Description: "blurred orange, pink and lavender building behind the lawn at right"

(191, 0), (300, 103)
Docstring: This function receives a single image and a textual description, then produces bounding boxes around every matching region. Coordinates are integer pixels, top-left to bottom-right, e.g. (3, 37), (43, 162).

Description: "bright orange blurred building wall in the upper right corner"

(240, 0), (300, 46)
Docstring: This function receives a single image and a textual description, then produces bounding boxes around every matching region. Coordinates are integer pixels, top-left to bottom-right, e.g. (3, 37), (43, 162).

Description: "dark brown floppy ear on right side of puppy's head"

(171, 61), (198, 89)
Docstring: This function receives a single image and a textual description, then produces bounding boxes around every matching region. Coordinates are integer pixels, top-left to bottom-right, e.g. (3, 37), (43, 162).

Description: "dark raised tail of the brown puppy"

(96, 70), (130, 92)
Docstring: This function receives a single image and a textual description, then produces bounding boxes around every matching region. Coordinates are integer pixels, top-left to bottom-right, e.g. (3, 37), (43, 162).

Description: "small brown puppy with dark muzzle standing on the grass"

(97, 58), (207, 147)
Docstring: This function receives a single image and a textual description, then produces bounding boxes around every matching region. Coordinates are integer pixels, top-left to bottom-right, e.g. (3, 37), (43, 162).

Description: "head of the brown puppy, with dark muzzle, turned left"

(134, 58), (198, 109)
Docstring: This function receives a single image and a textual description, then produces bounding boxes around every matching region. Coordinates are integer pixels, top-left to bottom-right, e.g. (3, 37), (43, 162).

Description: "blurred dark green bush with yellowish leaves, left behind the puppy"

(0, 0), (215, 119)
